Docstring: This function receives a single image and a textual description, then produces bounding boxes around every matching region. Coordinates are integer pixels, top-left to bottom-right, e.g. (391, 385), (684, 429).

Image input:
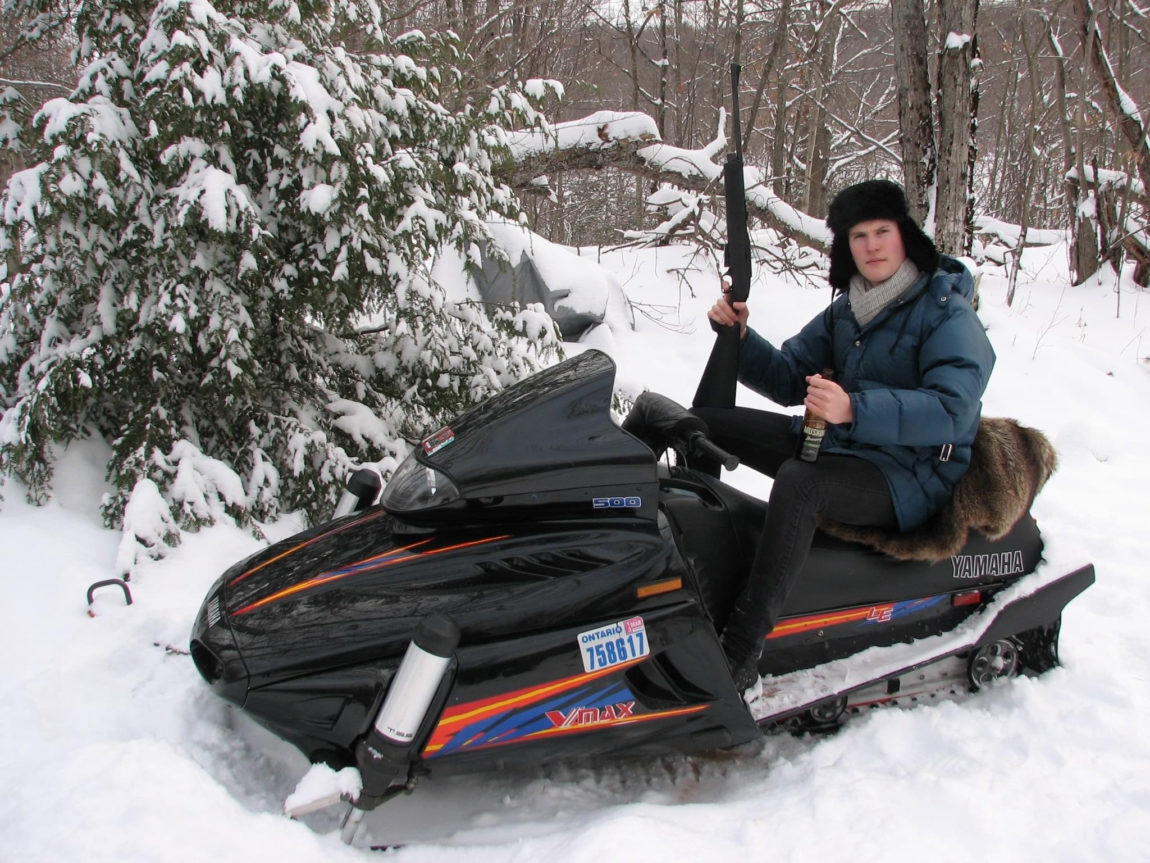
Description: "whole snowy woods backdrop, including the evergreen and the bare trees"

(0, 0), (1150, 568)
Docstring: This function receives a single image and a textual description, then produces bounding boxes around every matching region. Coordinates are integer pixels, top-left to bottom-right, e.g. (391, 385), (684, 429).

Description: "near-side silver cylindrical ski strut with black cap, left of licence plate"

(355, 614), (459, 809)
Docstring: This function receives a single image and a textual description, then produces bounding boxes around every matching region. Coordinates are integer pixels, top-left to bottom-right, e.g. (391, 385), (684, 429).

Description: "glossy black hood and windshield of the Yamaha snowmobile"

(196, 351), (666, 686)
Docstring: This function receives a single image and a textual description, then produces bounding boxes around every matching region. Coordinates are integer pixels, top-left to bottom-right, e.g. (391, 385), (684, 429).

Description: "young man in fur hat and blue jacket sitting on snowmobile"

(695, 180), (995, 689)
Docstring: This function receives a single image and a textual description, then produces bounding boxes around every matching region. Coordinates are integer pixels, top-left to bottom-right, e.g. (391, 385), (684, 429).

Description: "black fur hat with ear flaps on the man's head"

(827, 180), (938, 291)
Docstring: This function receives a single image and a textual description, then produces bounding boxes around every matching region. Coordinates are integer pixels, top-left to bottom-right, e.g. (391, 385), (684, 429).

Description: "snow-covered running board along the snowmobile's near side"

(744, 563), (1095, 727)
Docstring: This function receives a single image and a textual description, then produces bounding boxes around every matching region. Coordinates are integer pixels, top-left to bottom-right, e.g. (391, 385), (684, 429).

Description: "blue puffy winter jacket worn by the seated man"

(738, 255), (995, 530)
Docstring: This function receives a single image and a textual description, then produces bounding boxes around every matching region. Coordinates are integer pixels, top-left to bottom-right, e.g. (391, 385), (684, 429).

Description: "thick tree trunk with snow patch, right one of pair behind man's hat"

(935, 0), (979, 254)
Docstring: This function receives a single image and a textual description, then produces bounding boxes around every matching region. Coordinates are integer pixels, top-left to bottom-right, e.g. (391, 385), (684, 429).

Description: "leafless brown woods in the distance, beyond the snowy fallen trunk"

(8, 0), (1150, 269)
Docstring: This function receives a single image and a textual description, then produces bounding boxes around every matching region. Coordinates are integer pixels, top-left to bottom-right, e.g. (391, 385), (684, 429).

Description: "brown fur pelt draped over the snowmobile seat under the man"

(819, 417), (1057, 562)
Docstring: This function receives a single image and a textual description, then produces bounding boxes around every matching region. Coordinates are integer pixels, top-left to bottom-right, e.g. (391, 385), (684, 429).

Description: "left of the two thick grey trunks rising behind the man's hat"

(890, 0), (935, 221)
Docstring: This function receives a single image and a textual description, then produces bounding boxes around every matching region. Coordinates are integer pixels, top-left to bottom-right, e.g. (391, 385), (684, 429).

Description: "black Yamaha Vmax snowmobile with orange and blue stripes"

(190, 350), (1094, 841)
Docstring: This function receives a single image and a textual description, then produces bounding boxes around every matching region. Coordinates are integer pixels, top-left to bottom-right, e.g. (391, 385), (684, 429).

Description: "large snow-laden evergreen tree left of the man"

(0, 0), (558, 567)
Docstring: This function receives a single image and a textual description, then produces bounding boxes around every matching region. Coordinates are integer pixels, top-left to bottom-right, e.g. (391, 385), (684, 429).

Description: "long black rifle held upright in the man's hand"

(691, 63), (751, 407)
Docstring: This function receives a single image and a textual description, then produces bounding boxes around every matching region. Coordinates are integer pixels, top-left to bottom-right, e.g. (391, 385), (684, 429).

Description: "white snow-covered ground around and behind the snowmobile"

(0, 238), (1150, 863)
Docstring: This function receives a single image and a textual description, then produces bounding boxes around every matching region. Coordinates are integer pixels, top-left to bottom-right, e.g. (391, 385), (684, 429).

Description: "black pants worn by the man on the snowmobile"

(693, 407), (898, 667)
